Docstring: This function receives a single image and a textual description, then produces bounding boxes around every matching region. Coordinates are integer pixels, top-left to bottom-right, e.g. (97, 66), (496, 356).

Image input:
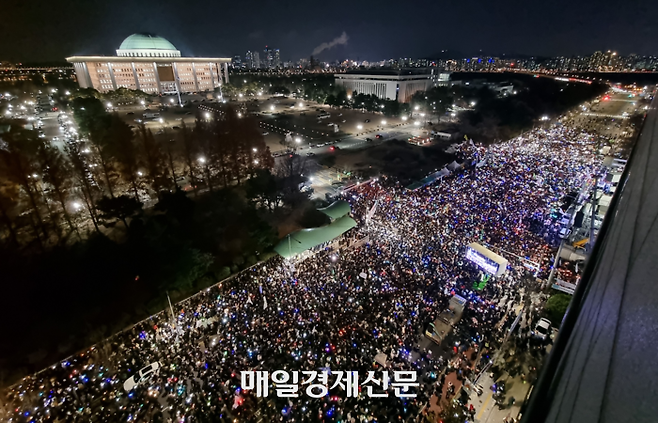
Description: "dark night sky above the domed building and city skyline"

(0, 0), (658, 62)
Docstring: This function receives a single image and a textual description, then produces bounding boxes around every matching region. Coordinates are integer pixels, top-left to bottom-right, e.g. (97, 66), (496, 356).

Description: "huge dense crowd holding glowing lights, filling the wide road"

(3, 126), (601, 423)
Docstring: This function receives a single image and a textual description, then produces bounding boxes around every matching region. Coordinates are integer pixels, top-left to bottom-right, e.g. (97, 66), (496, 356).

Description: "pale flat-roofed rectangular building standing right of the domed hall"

(334, 69), (432, 103)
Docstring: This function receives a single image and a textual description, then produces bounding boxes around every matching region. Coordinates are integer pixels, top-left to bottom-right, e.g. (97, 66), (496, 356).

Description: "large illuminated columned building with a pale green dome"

(66, 34), (231, 94)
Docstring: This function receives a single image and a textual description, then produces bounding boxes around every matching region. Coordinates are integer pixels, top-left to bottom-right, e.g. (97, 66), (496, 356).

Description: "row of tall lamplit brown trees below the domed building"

(0, 97), (274, 250)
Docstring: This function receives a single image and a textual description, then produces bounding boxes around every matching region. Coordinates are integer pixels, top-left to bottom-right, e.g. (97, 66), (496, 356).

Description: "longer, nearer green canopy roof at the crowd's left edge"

(274, 216), (357, 258)
